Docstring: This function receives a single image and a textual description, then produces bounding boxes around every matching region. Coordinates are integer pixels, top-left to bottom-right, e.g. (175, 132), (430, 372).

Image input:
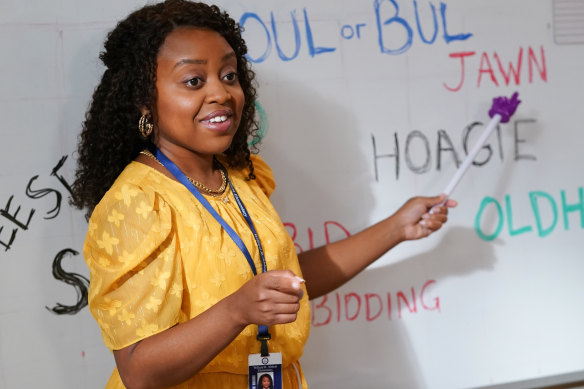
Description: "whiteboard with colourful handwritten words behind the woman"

(0, 0), (584, 388)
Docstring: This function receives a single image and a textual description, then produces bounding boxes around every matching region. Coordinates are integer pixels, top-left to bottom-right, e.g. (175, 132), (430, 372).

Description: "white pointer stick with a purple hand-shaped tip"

(430, 92), (521, 209)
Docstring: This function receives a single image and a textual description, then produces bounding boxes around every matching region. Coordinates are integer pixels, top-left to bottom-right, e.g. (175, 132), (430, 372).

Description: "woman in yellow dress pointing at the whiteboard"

(73, 0), (454, 388)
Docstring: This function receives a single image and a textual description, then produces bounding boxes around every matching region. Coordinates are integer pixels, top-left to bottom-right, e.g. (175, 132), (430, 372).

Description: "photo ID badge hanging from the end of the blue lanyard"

(247, 353), (282, 389)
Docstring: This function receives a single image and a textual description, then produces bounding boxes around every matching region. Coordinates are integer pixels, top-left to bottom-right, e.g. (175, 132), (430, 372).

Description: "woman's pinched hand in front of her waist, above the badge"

(231, 270), (304, 326)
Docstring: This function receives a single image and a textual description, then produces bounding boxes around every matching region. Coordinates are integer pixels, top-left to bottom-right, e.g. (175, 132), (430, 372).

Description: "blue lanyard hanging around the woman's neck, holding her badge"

(154, 146), (271, 355)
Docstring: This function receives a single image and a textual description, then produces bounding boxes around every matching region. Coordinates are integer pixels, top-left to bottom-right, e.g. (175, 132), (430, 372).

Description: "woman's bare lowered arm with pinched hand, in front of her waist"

(114, 270), (303, 389)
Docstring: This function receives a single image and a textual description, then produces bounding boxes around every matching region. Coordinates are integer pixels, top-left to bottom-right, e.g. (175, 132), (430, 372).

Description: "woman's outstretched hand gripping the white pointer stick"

(392, 194), (457, 240)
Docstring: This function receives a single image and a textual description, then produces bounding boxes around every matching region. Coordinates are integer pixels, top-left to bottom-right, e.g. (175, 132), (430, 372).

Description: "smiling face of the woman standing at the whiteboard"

(154, 27), (244, 164)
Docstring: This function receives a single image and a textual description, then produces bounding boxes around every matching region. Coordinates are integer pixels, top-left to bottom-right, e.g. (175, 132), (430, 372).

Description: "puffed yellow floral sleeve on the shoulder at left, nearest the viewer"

(83, 184), (183, 350)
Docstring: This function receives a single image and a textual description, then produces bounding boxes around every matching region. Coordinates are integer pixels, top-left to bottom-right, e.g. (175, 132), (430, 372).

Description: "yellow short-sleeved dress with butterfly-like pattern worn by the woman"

(83, 156), (310, 389)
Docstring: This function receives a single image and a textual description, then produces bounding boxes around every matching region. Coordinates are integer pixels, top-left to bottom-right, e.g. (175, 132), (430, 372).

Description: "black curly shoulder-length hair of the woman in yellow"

(71, 0), (258, 216)
